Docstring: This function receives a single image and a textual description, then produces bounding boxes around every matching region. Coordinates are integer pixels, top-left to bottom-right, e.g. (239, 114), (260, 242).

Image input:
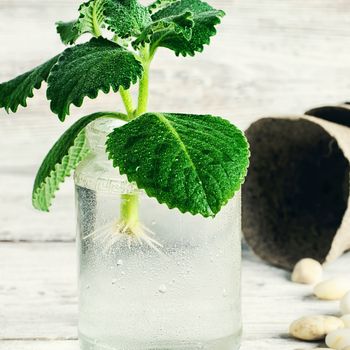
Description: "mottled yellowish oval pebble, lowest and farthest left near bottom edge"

(289, 315), (344, 340)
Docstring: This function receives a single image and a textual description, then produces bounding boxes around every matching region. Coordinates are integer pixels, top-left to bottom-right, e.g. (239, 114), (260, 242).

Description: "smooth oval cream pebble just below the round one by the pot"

(314, 277), (350, 300)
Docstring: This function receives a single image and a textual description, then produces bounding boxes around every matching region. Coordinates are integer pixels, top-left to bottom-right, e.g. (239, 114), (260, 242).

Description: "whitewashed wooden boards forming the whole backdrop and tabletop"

(0, 0), (350, 350)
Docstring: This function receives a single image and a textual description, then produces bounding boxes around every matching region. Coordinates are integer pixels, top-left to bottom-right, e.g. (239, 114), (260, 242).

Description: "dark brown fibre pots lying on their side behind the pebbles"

(242, 104), (350, 270)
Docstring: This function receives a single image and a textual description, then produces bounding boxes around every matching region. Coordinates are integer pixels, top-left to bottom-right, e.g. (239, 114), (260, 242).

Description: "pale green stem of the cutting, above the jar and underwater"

(120, 45), (151, 227)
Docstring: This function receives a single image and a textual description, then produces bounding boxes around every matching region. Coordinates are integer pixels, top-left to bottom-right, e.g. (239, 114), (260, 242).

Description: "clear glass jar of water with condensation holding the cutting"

(75, 119), (241, 350)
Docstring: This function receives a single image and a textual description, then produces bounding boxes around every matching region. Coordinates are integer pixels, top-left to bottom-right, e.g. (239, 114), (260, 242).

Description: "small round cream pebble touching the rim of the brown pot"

(291, 258), (323, 284)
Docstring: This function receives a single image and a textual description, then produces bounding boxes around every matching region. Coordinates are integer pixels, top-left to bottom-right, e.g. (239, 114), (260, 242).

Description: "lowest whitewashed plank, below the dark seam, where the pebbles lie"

(0, 243), (350, 350)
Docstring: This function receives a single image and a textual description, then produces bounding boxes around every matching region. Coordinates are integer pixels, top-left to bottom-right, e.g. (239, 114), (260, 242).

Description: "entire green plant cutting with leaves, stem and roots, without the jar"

(0, 0), (249, 248)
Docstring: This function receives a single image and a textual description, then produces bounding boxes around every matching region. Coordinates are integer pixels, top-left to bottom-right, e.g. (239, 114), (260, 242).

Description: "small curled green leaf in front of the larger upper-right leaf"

(133, 11), (194, 48)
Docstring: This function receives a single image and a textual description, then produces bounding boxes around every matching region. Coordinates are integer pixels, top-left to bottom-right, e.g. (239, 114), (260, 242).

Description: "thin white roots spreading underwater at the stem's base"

(84, 220), (163, 254)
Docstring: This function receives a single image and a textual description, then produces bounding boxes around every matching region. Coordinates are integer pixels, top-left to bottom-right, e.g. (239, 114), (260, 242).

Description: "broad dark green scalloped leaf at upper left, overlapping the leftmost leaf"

(47, 38), (143, 121)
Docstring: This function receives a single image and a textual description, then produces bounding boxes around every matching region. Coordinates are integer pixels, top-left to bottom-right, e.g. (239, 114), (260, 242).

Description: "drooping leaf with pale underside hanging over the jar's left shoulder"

(32, 112), (124, 211)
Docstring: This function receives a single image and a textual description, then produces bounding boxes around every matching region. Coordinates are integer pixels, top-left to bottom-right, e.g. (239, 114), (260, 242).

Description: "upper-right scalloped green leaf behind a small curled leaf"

(151, 0), (225, 56)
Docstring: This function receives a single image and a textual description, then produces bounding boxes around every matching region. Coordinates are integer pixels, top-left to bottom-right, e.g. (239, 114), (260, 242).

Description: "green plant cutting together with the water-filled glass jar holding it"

(0, 0), (249, 349)
